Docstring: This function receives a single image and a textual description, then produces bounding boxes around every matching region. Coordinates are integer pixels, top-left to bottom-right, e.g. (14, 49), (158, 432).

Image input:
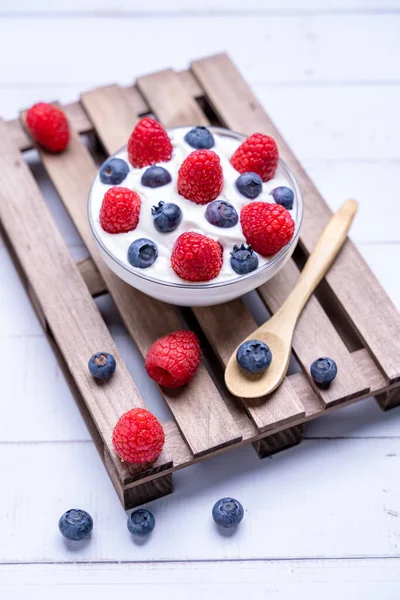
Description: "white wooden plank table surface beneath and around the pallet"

(0, 0), (400, 600)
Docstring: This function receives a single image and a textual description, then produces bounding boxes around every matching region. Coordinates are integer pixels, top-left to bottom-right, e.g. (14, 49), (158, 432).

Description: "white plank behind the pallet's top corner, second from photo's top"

(0, 14), (400, 89)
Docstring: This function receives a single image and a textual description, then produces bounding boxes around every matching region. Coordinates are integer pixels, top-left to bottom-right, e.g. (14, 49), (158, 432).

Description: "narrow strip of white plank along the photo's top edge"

(2, 0), (400, 16)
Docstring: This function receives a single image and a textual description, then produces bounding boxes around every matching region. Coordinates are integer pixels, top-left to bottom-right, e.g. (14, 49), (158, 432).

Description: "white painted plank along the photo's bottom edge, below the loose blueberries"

(0, 559), (400, 600)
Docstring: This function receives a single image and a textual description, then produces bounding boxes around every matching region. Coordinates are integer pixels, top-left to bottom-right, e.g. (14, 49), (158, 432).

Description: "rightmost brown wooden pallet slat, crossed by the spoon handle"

(192, 54), (400, 381)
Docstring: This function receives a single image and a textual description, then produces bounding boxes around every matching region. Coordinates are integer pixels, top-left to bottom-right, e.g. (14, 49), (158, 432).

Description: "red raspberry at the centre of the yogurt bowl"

(178, 150), (224, 204)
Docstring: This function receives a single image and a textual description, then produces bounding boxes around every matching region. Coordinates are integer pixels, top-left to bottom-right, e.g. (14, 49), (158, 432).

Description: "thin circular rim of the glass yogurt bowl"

(88, 125), (304, 290)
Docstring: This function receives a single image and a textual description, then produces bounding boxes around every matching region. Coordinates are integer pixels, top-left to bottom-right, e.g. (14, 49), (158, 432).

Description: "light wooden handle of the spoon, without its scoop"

(281, 200), (358, 321)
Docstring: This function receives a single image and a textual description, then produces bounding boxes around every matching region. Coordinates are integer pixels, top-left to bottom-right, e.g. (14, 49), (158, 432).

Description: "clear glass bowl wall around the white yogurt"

(88, 127), (303, 306)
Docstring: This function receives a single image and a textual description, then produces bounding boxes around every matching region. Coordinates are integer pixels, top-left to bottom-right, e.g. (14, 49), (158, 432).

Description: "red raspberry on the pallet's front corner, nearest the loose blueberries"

(112, 408), (165, 463)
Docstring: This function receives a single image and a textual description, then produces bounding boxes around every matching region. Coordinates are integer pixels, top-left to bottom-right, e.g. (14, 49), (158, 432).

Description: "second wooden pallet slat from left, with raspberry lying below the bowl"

(24, 106), (241, 456)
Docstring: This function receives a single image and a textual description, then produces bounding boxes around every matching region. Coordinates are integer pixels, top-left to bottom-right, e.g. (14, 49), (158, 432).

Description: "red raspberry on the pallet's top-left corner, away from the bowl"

(26, 102), (69, 152)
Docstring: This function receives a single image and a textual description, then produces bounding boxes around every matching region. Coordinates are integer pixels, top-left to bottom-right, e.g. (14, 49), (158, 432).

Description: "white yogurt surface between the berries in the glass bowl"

(89, 127), (292, 286)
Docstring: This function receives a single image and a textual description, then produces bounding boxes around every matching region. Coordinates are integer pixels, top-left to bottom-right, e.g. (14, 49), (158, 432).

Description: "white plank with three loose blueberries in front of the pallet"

(0, 438), (400, 562)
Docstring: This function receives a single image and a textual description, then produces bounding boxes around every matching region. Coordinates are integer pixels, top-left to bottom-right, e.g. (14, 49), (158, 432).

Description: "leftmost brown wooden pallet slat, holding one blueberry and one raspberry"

(0, 122), (171, 481)
